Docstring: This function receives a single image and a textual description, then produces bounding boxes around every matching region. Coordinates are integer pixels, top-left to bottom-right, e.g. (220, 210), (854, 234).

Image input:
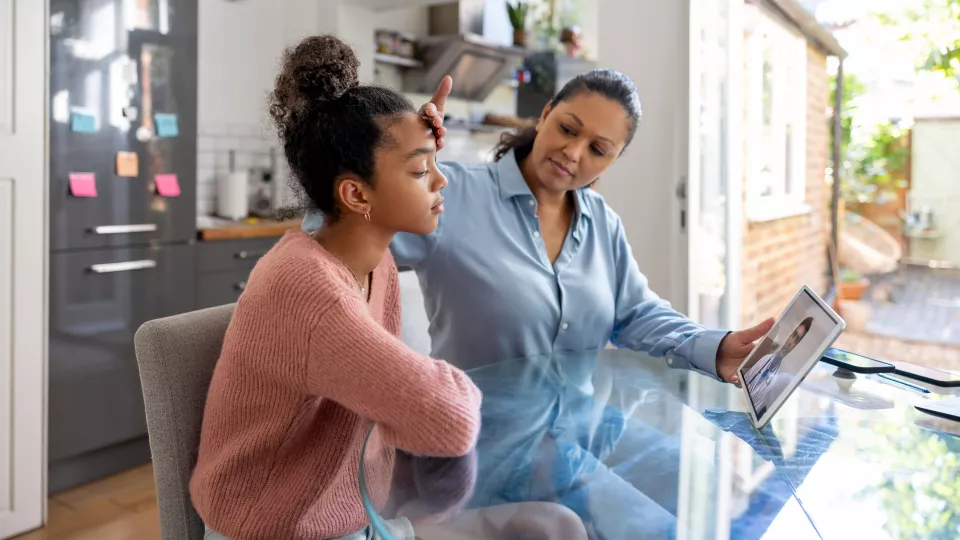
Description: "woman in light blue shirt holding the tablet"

(303, 70), (773, 538)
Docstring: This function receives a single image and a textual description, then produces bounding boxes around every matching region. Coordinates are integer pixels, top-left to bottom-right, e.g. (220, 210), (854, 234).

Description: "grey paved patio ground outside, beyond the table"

(867, 266), (960, 347)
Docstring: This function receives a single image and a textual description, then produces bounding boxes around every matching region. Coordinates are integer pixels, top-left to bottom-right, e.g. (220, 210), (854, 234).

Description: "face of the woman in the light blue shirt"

(524, 92), (631, 192)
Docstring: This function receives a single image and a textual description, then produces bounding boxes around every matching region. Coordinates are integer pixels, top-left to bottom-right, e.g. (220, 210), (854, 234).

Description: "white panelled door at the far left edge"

(0, 0), (47, 538)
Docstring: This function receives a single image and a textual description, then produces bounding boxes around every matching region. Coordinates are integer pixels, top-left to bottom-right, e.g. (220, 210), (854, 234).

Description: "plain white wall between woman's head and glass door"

(597, 0), (689, 310)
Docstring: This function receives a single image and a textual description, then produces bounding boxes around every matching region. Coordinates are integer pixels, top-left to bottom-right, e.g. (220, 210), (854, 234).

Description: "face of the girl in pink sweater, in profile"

(367, 112), (447, 234)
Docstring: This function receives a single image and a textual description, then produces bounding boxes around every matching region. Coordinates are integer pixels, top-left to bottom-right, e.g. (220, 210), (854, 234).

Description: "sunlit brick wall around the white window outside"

(741, 47), (830, 326)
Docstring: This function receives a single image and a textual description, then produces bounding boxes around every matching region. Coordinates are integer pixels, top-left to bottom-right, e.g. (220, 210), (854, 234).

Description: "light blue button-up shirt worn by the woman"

(303, 148), (727, 378)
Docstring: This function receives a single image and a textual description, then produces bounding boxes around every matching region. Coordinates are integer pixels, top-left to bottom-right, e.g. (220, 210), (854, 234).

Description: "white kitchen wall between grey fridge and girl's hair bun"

(197, 0), (378, 215)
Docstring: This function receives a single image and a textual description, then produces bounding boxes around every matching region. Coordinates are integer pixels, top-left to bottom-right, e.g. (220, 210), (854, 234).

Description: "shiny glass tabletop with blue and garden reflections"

(360, 350), (960, 540)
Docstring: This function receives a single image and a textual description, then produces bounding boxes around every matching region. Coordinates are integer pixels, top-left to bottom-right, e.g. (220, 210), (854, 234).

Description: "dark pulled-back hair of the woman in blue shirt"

(493, 69), (642, 161)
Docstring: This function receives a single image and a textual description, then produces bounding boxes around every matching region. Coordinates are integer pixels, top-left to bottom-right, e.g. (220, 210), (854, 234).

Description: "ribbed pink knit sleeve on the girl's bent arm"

(305, 296), (481, 457)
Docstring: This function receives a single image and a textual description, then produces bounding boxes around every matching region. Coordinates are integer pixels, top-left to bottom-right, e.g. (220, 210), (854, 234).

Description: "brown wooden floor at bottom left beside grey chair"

(14, 465), (160, 540)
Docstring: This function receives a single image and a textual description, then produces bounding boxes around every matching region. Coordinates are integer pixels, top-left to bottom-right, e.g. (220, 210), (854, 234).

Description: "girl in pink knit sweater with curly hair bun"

(190, 36), (582, 540)
